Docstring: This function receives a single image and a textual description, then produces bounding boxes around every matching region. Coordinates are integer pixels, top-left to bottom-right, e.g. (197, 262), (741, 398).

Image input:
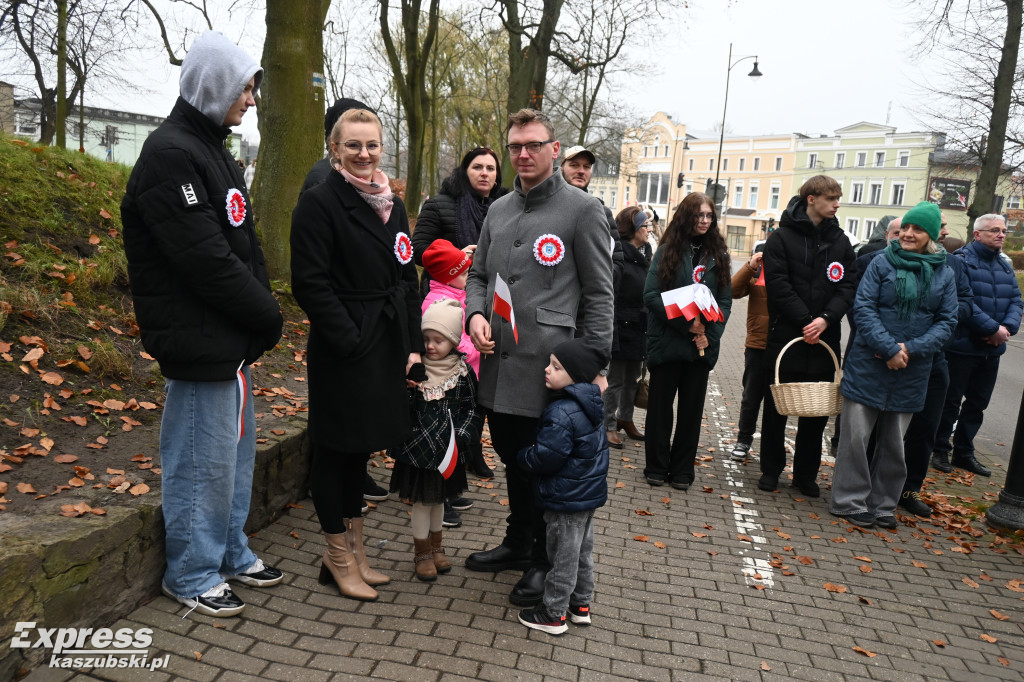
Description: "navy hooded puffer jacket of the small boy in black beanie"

(519, 384), (608, 512)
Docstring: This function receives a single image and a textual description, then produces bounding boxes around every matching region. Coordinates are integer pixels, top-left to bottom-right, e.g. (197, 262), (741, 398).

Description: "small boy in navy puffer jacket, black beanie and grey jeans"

(519, 339), (608, 635)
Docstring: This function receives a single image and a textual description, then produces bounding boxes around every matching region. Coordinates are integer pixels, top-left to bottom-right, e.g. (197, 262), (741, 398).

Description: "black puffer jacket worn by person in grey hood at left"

(121, 97), (284, 381)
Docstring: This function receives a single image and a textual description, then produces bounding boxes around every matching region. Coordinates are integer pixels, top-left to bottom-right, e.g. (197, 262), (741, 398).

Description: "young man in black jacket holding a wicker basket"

(758, 175), (857, 498)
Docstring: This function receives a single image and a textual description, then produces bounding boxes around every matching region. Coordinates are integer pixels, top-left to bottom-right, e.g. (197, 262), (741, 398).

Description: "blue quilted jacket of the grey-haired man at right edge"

(946, 242), (1024, 355)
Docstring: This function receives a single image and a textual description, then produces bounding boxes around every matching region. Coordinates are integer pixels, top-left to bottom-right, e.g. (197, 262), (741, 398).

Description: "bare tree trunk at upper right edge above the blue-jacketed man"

(967, 0), (1024, 231)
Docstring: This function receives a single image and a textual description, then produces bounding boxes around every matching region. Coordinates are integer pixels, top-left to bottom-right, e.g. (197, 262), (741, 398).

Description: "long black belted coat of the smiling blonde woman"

(292, 172), (423, 453)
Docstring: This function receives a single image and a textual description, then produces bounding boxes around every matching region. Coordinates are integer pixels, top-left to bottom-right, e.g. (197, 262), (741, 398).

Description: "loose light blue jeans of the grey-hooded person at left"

(160, 367), (256, 597)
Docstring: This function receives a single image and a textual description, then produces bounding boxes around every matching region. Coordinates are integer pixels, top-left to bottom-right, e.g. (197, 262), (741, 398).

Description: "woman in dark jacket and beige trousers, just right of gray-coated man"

(602, 206), (653, 449)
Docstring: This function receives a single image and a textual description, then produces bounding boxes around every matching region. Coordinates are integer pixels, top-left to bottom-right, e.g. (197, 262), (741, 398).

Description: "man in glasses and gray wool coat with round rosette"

(466, 109), (614, 606)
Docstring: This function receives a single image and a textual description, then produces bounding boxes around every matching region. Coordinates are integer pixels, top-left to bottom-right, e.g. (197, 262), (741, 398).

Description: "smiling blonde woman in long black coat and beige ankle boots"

(292, 109), (423, 601)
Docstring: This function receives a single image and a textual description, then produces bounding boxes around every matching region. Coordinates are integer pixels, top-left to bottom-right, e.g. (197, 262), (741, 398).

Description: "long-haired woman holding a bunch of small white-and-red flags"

(643, 193), (732, 491)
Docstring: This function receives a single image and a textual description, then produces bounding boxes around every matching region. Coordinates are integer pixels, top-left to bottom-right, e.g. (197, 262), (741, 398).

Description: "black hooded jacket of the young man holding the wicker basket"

(764, 197), (857, 371)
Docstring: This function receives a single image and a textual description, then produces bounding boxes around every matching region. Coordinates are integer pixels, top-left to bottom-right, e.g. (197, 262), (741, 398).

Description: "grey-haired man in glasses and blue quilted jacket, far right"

(932, 213), (1024, 476)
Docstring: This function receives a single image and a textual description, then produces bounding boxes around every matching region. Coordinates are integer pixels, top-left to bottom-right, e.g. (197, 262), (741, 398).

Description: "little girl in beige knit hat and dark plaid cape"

(390, 296), (483, 581)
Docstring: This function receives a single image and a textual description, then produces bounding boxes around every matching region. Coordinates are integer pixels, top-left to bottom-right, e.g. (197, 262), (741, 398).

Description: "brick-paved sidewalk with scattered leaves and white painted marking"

(27, 301), (1024, 682)
